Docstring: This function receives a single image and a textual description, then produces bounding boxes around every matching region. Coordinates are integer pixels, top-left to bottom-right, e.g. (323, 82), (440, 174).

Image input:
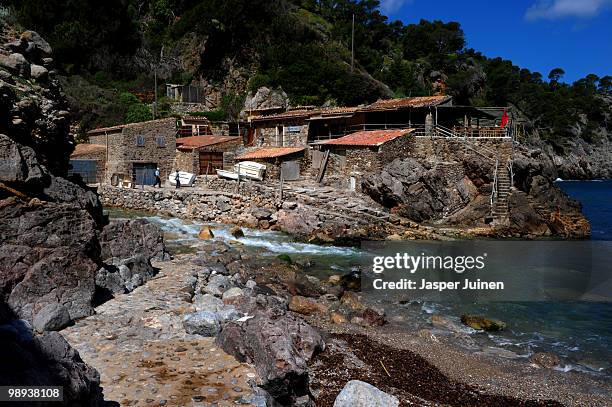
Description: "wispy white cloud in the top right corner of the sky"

(525, 0), (612, 21)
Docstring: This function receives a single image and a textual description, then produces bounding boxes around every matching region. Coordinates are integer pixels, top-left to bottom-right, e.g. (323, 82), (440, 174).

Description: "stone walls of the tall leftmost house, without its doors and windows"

(89, 118), (176, 182)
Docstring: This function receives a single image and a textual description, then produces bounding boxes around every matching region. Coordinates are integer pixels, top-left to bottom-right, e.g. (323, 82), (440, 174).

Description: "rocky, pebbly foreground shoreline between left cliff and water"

(62, 233), (610, 406)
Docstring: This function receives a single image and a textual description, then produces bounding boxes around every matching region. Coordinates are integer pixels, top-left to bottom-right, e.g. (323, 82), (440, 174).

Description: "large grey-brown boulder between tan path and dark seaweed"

(216, 309), (324, 405)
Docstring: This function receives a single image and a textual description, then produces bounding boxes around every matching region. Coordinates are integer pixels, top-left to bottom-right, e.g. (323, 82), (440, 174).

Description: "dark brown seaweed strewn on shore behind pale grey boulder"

(310, 334), (563, 407)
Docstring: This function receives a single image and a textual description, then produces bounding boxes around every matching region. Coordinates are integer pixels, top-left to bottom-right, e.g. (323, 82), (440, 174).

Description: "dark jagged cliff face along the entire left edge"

(0, 26), (103, 406)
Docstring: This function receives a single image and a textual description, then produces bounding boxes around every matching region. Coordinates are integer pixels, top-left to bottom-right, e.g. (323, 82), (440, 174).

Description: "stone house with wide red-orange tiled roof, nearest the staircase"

(312, 129), (415, 179)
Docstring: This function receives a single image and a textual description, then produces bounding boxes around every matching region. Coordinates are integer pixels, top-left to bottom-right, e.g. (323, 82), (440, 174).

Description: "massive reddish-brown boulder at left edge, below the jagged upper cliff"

(0, 198), (99, 321)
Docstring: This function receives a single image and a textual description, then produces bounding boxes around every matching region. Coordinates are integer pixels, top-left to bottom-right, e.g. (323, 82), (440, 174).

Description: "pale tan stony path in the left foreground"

(62, 258), (258, 406)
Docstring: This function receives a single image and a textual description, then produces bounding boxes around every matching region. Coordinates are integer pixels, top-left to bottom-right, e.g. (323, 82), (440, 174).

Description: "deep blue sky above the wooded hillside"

(380, 0), (612, 82)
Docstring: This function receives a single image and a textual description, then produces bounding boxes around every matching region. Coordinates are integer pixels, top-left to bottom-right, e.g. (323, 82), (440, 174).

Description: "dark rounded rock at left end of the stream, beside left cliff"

(100, 219), (170, 260)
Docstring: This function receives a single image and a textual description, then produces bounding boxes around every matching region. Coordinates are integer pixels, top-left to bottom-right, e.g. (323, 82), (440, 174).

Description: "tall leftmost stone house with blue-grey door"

(87, 118), (176, 185)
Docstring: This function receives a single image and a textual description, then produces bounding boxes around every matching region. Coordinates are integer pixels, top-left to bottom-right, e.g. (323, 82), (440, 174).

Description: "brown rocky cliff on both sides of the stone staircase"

(363, 143), (590, 238)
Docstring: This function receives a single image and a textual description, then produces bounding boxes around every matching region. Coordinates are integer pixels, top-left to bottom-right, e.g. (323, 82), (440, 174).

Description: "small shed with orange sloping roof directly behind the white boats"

(236, 147), (307, 181)
